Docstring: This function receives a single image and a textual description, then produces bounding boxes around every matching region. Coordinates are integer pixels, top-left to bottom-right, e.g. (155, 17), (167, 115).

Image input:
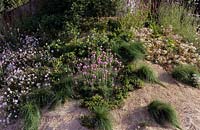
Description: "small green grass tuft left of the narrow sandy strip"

(135, 65), (157, 82)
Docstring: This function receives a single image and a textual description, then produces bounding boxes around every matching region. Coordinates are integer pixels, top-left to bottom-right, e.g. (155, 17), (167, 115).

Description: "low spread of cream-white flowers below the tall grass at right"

(135, 26), (200, 70)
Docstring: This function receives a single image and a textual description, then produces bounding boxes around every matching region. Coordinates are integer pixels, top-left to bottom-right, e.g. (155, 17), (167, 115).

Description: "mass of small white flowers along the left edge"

(0, 36), (51, 124)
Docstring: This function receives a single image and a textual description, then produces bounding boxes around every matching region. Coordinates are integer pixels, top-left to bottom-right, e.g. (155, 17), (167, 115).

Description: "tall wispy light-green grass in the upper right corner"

(159, 4), (198, 42)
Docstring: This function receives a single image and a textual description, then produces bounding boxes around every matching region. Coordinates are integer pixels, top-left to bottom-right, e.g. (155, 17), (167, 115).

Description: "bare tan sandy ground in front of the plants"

(3, 62), (200, 130)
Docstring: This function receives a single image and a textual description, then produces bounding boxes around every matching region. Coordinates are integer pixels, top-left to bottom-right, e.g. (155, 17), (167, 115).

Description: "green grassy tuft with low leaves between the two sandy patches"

(81, 106), (112, 130)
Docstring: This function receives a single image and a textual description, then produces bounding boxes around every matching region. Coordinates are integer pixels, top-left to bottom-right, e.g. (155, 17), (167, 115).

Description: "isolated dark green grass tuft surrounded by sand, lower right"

(148, 100), (181, 129)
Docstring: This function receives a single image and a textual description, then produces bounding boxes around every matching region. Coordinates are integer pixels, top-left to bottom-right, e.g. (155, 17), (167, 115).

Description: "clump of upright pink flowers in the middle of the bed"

(75, 47), (123, 96)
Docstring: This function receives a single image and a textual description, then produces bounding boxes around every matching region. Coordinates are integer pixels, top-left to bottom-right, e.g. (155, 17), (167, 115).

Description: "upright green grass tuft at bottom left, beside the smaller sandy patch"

(21, 103), (40, 130)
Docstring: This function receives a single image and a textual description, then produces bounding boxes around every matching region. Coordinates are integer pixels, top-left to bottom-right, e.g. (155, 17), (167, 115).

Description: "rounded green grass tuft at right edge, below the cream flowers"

(172, 65), (199, 87)
